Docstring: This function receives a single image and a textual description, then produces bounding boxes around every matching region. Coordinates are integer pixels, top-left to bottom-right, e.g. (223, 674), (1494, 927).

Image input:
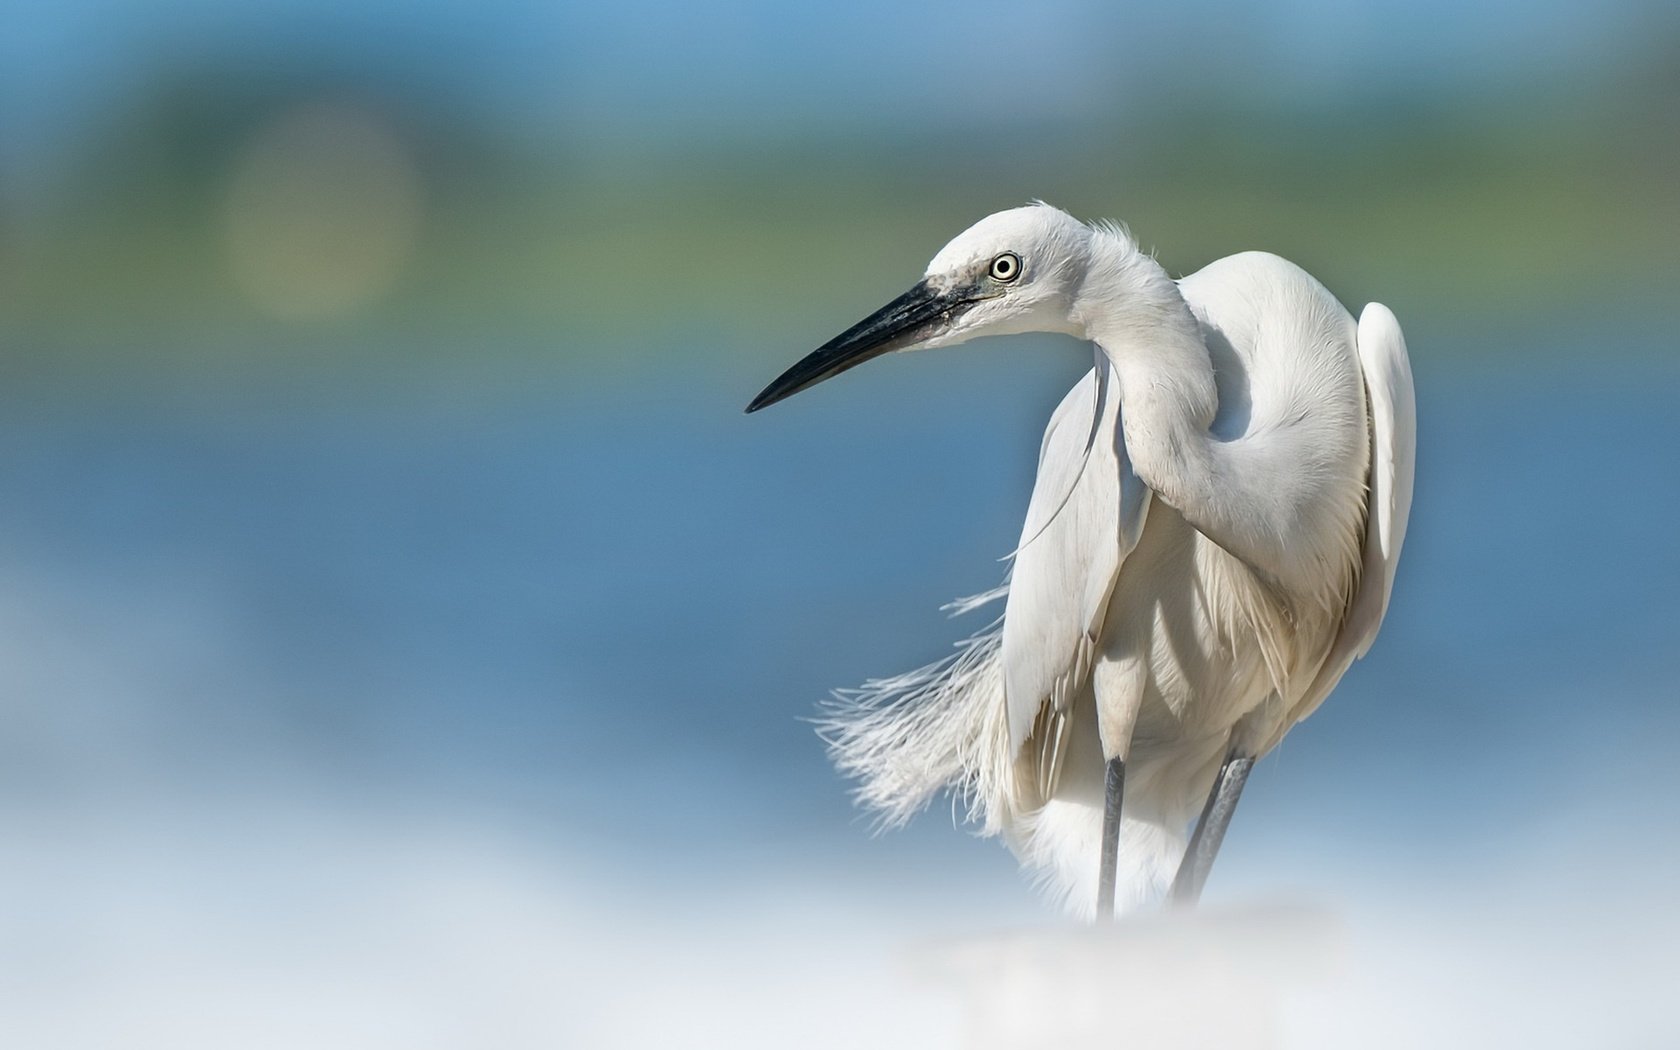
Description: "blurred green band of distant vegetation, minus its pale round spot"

(0, 57), (1680, 370)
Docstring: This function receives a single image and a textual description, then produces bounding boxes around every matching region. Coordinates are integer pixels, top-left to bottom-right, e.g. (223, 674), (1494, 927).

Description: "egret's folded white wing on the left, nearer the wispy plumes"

(1003, 348), (1149, 798)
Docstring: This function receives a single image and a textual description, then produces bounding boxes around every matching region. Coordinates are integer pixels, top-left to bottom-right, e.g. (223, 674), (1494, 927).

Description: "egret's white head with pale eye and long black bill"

(748, 203), (1092, 412)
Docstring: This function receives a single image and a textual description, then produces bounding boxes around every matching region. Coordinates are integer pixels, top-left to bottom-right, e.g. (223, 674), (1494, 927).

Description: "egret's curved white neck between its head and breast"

(1075, 232), (1294, 583)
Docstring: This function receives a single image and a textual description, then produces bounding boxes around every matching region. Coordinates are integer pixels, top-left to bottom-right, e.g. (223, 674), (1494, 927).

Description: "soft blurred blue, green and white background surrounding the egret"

(0, 0), (1680, 1048)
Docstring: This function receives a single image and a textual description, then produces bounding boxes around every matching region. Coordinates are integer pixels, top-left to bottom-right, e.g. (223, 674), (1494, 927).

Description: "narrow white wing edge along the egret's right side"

(1273, 302), (1418, 732)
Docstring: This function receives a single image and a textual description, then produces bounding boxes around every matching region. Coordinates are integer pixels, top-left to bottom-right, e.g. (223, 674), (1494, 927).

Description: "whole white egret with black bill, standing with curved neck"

(748, 203), (1416, 916)
